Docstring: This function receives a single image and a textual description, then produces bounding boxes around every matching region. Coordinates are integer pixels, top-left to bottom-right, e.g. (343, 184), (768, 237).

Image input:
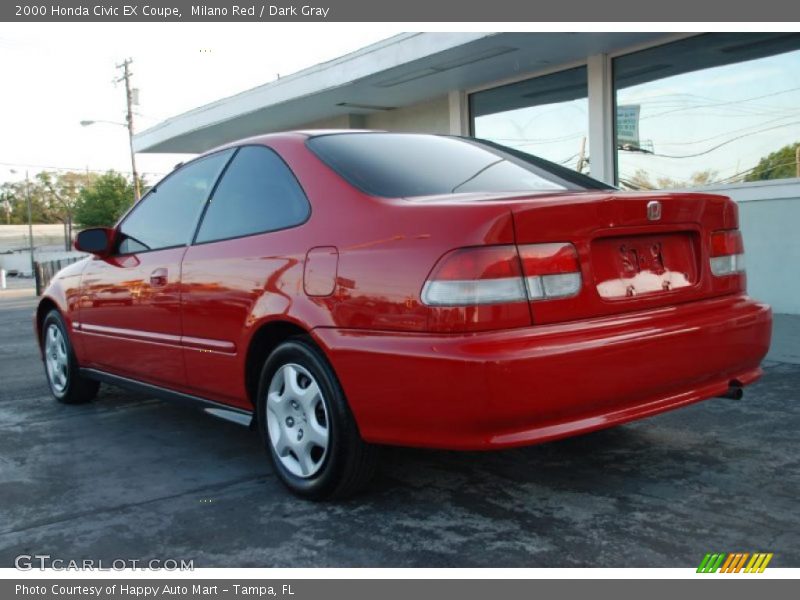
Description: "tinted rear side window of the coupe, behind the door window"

(196, 146), (310, 243)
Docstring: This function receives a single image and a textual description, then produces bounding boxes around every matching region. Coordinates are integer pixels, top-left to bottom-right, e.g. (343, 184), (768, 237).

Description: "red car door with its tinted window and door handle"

(79, 150), (233, 387)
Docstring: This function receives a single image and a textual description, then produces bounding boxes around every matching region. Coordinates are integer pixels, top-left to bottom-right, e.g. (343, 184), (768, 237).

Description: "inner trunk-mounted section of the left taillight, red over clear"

(519, 243), (581, 300)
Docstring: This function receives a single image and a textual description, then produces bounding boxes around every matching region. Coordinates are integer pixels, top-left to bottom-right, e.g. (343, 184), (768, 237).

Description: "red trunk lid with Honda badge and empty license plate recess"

(508, 191), (744, 323)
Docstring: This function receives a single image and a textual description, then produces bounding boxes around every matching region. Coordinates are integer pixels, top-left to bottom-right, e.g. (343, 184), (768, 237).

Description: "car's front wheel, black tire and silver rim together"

(42, 310), (100, 404)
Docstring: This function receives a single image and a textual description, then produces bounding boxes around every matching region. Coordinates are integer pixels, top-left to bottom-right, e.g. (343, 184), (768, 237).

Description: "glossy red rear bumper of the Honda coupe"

(314, 296), (772, 449)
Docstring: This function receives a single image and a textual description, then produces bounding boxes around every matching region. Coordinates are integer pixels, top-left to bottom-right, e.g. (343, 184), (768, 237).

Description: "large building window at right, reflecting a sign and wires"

(614, 33), (800, 189)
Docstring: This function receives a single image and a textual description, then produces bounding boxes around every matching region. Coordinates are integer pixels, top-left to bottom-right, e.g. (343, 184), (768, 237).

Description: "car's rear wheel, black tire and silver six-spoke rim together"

(257, 338), (378, 500)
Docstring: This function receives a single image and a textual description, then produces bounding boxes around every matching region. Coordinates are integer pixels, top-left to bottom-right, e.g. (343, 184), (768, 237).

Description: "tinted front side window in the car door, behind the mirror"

(118, 150), (233, 254)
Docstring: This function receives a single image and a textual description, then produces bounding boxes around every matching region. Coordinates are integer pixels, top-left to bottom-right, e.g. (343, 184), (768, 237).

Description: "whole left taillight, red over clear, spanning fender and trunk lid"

(422, 243), (581, 306)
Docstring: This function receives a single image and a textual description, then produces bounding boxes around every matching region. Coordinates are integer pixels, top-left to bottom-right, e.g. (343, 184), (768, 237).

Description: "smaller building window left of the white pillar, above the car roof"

(470, 67), (589, 173)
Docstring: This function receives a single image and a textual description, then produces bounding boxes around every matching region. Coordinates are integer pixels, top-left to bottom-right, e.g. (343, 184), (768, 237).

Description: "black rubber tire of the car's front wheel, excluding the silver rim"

(42, 309), (100, 404)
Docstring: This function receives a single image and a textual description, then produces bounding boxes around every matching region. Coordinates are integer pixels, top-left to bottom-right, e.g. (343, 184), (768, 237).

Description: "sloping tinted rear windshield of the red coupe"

(307, 133), (609, 198)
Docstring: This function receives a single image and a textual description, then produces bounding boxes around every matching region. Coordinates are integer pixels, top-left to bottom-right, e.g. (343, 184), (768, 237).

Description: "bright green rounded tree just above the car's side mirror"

(75, 171), (133, 227)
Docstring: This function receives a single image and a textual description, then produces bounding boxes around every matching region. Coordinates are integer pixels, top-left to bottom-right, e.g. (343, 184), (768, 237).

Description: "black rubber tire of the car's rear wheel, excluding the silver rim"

(256, 337), (379, 500)
